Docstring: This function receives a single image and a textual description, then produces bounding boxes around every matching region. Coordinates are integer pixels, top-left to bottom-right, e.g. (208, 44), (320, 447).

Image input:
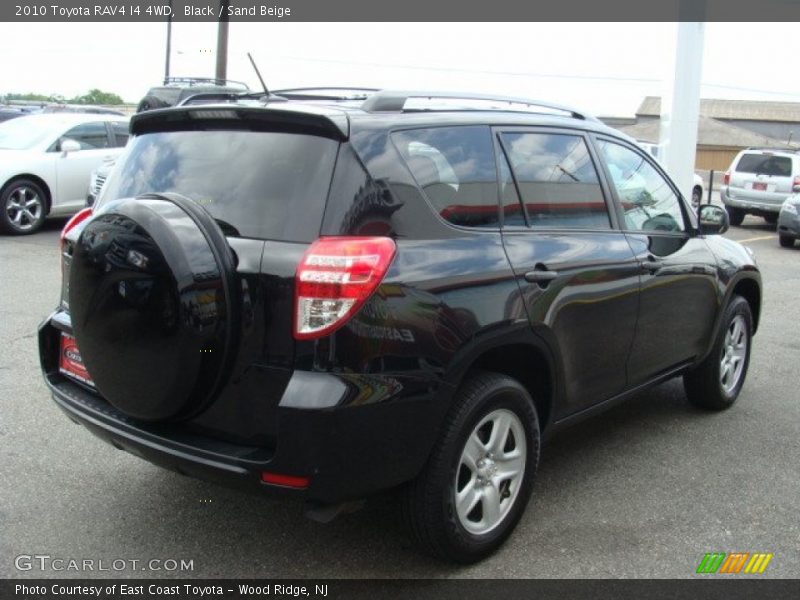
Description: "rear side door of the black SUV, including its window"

(496, 129), (639, 418)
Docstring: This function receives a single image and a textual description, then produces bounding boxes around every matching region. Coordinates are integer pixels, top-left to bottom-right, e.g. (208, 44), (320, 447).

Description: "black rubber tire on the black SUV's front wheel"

(683, 296), (753, 410)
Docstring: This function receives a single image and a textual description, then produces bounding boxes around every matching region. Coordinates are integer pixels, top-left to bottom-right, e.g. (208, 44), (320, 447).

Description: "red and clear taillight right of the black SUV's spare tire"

(294, 237), (397, 340)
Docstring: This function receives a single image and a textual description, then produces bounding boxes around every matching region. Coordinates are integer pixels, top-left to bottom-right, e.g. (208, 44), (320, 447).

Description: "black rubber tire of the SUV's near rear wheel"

(403, 372), (540, 564)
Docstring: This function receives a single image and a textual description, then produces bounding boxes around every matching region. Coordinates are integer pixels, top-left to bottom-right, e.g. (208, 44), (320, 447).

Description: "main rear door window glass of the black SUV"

(502, 133), (611, 229)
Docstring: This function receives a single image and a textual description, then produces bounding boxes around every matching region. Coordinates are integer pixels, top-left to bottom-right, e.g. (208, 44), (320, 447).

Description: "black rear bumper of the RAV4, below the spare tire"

(39, 315), (446, 503)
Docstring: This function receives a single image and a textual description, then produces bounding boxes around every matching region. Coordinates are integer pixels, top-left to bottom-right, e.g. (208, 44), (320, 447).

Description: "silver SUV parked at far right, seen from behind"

(720, 148), (800, 225)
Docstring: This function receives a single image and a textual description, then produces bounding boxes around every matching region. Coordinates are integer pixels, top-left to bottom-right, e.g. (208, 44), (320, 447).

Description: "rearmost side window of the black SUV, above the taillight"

(392, 126), (499, 227)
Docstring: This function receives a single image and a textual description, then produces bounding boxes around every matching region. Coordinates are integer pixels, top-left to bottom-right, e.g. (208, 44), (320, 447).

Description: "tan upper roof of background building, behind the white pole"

(636, 96), (800, 123)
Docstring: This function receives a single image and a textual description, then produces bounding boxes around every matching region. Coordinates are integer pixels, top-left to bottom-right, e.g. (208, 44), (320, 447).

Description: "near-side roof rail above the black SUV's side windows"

(361, 90), (598, 121)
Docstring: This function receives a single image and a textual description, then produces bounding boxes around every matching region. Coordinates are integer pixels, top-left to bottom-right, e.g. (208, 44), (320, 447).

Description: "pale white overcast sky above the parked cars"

(0, 23), (800, 116)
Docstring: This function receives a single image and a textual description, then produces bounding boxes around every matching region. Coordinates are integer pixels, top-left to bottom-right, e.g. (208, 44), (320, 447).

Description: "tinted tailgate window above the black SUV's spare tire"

(102, 131), (339, 242)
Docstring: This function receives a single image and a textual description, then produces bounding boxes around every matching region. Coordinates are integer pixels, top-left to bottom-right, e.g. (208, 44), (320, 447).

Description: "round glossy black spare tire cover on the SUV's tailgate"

(69, 195), (237, 421)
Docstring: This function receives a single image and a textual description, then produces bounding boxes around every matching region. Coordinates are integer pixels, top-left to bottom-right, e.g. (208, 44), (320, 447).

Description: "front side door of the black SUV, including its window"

(596, 137), (719, 385)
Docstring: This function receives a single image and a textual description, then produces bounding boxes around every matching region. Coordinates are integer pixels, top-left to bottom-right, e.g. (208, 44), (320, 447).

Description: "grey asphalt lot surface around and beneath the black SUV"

(0, 217), (800, 579)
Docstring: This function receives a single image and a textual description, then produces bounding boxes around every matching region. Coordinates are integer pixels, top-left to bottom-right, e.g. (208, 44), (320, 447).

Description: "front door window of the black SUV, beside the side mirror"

(599, 140), (685, 231)
